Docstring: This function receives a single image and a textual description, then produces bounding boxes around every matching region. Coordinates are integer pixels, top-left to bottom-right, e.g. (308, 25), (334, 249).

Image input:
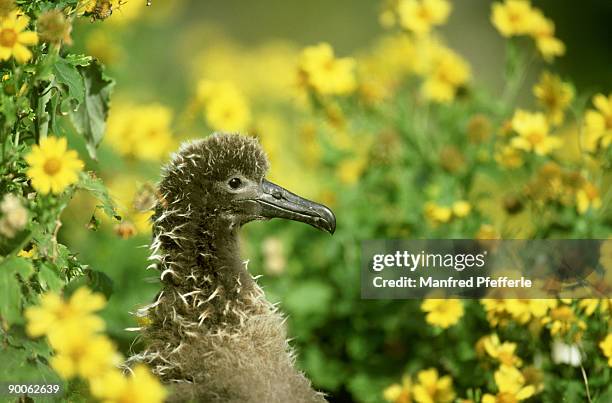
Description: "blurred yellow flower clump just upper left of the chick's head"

(105, 104), (174, 161)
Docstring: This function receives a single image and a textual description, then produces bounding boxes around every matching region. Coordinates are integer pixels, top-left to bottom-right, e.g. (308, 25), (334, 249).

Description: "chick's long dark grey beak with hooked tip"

(254, 179), (336, 234)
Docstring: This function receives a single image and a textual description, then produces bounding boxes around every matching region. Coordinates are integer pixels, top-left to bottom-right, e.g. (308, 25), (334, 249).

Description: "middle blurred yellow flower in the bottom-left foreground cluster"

(49, 328), (121, 379)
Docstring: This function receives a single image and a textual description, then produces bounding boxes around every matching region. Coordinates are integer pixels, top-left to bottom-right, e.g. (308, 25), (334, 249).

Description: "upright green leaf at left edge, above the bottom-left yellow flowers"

(0, 257), (34, 324)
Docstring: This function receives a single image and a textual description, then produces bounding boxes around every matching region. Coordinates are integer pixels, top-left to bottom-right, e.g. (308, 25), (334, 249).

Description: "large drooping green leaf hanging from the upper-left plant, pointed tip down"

(70, 61), (115, 159)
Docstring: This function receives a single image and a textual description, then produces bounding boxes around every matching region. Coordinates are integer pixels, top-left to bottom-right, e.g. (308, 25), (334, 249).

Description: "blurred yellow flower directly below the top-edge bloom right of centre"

(422, 47), (471, 103)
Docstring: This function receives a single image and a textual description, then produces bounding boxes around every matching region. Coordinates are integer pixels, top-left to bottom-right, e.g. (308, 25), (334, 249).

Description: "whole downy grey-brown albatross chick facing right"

(130, 134), (336, 403)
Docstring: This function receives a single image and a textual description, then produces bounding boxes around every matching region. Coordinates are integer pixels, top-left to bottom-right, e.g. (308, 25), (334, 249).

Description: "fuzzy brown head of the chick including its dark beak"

(160, 133), (336, 233)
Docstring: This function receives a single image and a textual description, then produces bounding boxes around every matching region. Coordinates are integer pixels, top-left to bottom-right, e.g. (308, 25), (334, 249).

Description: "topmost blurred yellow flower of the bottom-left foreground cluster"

(25, 287), (106, 337)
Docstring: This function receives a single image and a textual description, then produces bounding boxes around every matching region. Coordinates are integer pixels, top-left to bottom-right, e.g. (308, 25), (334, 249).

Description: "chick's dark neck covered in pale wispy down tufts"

(152, 214), (267, 330)
